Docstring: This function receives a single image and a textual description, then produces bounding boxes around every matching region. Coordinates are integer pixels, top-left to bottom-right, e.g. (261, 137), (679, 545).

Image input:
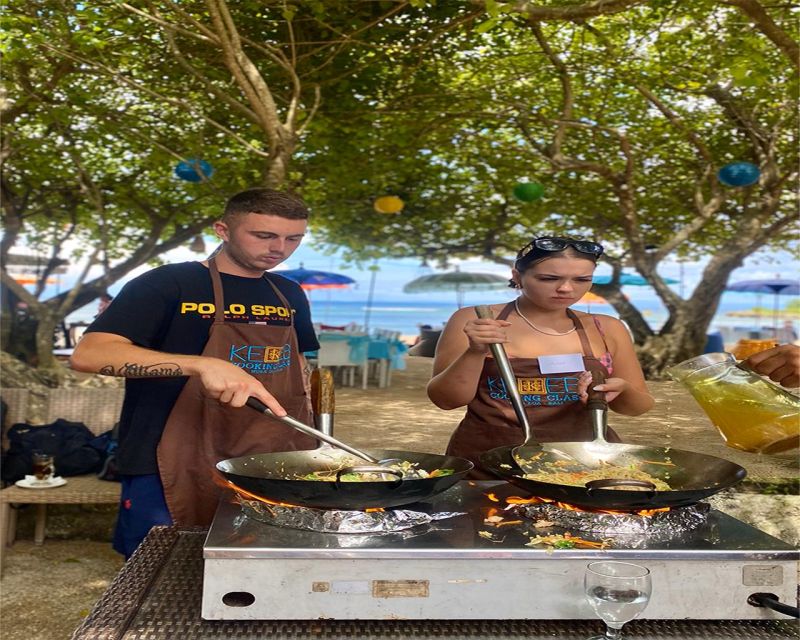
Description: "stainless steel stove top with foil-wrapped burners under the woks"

(202, 482), (800, 620)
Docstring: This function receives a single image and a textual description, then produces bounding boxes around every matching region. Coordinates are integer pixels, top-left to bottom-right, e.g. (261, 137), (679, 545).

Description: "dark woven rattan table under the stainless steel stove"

(73, 527), (798, 640)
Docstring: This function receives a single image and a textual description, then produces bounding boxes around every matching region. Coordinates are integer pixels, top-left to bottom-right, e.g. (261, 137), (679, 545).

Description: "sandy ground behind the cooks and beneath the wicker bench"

(0, 358), (800, 640)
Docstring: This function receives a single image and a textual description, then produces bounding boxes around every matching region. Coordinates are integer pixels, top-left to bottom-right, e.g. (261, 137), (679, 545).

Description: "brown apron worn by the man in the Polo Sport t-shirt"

(158, 258), (316, 526)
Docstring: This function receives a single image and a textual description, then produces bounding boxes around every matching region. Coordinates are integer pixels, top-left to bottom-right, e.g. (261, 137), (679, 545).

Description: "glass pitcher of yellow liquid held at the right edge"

(666, 353), (800, 453)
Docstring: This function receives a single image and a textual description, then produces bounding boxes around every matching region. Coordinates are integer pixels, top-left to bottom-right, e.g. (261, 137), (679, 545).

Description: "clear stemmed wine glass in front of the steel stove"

(583, 560), (652, 640)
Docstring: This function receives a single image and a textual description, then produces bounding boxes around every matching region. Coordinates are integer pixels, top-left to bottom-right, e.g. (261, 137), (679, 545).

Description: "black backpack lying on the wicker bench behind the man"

(2, 418), (105, 482)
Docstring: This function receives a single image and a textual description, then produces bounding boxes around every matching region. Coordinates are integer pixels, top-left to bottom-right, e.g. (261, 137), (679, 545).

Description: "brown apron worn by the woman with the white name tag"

(447, 302), (619, 480)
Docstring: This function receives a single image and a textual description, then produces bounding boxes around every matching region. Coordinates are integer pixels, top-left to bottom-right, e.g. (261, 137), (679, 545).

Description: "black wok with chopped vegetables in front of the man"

(217, 449), (473, 509)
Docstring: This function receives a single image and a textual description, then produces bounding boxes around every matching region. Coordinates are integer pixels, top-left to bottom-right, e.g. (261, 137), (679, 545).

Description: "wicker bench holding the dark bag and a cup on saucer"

(0, 387), (125, 570)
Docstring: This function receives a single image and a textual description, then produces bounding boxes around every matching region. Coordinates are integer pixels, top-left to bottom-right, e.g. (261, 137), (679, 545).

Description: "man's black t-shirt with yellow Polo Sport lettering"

(86, 262), (319, 475)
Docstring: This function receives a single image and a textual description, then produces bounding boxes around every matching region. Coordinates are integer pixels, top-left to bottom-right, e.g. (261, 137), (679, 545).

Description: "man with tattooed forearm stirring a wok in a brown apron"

(71, 188), (319, 557)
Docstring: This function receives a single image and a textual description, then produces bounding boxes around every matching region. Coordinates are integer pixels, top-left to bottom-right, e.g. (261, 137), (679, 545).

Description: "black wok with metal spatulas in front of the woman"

(479, 309), (747, 511)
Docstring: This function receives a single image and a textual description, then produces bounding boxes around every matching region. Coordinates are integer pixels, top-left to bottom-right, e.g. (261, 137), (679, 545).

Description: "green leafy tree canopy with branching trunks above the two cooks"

(0, 0), (798, 372)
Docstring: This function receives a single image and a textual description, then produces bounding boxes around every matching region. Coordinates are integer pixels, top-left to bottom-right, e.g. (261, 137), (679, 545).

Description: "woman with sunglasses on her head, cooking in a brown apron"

(428, 236), (653, 479)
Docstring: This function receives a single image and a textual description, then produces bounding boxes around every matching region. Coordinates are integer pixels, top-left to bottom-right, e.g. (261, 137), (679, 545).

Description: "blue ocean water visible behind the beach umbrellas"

(311, 292), (800, 335)
